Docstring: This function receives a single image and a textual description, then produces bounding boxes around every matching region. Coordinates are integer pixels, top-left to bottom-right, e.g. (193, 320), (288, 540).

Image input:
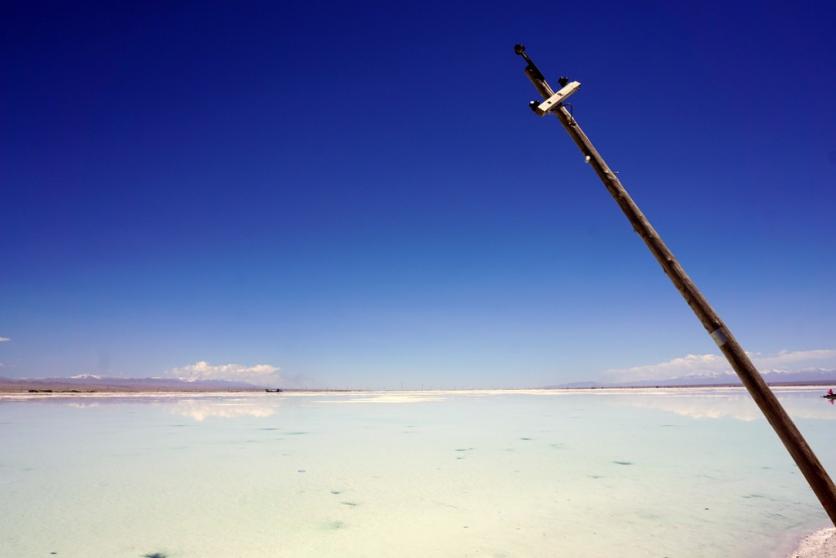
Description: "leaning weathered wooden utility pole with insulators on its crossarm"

(514, 45), (836, 525)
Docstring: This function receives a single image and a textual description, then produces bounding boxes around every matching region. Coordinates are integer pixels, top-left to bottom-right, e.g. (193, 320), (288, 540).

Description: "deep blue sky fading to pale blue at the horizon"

(0, 2), (836, 387)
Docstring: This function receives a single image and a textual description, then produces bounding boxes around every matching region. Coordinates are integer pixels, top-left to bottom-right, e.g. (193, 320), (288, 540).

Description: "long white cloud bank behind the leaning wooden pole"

(606, 349), (836, 381)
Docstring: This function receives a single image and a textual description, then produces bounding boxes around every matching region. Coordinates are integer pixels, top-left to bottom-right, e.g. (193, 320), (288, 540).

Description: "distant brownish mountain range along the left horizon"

(0, 374), (265, 393)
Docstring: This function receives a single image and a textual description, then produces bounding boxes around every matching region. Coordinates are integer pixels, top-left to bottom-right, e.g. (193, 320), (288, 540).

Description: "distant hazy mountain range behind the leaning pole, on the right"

(547, 368), (836, 388)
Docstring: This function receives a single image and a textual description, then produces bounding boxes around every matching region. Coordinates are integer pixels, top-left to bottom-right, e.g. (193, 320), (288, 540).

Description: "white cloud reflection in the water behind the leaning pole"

(623, 388), (836, 422)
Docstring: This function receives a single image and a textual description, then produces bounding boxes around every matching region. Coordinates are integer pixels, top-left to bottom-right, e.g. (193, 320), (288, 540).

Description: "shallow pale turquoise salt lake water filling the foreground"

(0, 388), (836, 558)
